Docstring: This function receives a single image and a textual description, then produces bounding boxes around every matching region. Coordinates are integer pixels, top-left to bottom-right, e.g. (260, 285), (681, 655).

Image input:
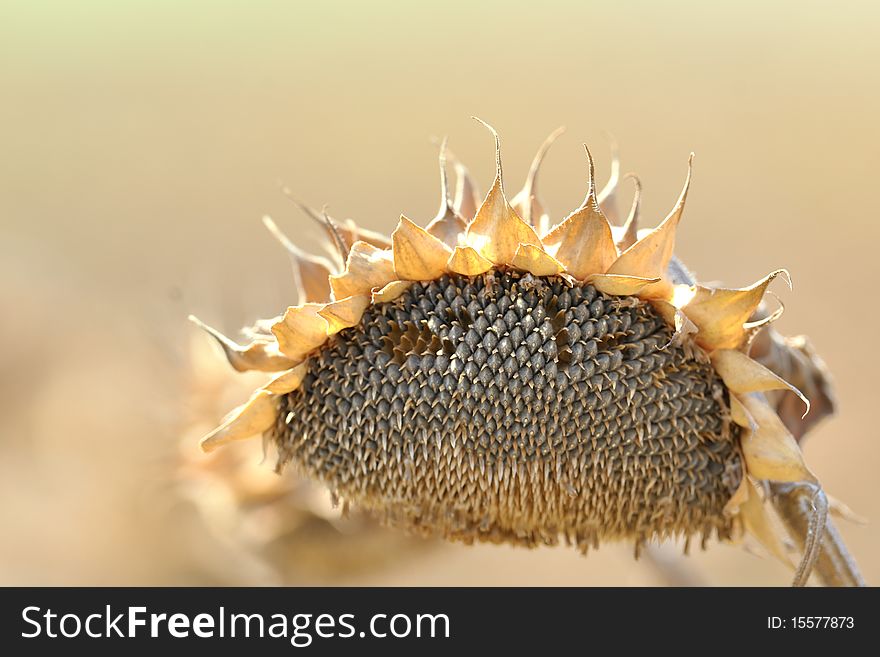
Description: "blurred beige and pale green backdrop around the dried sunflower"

(0, 0), (880, 585)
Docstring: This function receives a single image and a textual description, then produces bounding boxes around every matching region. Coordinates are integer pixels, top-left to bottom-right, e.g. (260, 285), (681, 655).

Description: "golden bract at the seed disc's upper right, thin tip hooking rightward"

(684, 269), (788, 349)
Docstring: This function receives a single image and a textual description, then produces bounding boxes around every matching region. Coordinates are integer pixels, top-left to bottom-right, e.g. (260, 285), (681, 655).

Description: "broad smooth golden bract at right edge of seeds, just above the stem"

(736, 393), (817, 483)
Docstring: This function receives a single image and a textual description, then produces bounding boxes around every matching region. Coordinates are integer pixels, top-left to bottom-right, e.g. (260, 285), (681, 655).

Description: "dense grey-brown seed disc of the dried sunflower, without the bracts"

(270, 270), (743, 551)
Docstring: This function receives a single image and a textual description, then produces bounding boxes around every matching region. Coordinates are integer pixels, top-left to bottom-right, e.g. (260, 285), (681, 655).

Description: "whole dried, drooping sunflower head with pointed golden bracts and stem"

(191, 120), (858, 584)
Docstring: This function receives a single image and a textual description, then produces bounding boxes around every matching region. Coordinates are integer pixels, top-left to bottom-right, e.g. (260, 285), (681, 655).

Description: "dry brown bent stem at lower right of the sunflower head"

(770, 483), (866, 586)
